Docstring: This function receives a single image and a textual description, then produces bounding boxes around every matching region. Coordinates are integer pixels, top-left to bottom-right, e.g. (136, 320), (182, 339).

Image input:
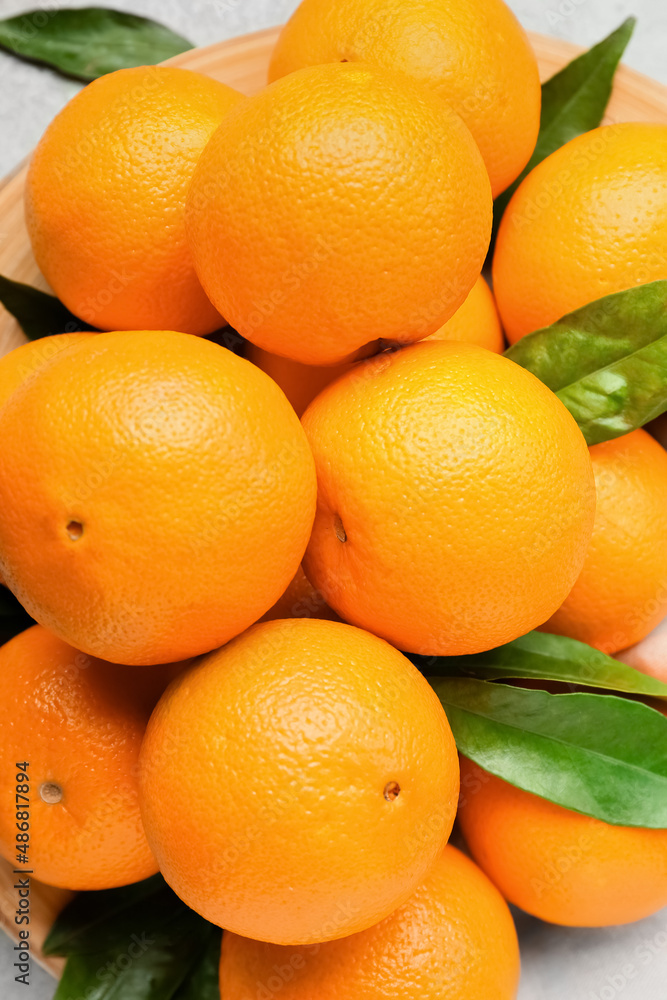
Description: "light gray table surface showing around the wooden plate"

(0, 0), (667, 1000)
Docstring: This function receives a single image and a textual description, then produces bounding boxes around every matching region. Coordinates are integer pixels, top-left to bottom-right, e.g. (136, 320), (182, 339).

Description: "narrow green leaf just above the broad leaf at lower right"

(411, 632), (667, 698)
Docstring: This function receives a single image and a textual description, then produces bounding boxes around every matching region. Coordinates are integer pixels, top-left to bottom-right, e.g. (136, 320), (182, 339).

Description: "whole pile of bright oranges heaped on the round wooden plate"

(0, 0), (667, 1000)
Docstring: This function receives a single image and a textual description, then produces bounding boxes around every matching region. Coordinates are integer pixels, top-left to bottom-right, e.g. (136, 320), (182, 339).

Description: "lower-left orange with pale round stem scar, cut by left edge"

(0, 625), (159, 889)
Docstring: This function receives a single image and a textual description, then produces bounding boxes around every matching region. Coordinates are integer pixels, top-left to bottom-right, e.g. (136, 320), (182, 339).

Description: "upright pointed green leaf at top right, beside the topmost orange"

(493, 17), (637, 236)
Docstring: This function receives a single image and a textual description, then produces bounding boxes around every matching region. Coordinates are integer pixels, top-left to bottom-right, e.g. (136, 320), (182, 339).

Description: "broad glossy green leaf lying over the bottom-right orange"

(431, 678), (667, 829)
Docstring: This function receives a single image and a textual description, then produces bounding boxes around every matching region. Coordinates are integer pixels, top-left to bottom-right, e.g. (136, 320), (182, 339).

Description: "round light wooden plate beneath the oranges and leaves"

(0, 28), (667, 975)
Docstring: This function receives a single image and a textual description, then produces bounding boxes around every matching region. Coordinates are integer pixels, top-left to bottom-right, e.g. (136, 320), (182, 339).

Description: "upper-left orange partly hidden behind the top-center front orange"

(26, 66), (241, 334)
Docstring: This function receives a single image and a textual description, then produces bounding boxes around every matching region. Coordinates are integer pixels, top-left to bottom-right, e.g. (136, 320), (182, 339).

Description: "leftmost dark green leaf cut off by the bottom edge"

(54, 904), (210, 1000)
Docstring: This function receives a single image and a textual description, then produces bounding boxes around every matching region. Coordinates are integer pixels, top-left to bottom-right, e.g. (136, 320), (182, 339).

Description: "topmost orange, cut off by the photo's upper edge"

(269, 0), (541, 198)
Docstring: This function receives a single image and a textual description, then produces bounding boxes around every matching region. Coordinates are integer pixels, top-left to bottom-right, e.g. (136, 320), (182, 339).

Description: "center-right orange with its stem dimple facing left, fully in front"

(302, 342), (595, 656)
